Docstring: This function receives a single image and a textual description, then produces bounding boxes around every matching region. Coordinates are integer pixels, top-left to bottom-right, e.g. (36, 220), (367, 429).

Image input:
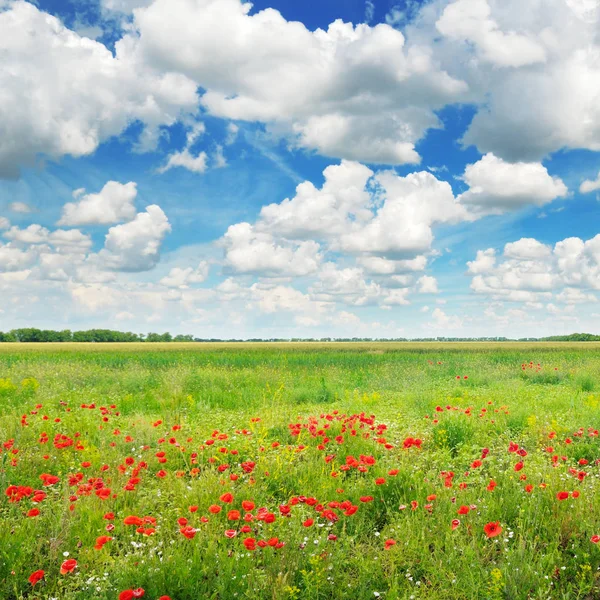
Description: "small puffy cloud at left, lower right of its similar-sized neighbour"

(98, 204), (171, 271)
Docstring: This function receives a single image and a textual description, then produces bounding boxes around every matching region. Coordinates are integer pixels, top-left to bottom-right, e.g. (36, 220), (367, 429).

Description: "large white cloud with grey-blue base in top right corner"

(436, 0), (600, 162)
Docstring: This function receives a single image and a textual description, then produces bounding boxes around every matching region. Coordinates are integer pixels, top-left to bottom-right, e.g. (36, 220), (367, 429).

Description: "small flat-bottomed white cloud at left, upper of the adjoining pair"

(58, 181), (137, 225)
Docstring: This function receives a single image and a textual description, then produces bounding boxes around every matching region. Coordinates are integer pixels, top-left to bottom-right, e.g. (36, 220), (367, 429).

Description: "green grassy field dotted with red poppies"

(0, 343), (600, 600)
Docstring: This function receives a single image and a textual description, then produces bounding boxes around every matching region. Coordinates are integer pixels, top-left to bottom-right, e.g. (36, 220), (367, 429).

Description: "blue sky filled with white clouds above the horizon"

(0, 0), (600, 338)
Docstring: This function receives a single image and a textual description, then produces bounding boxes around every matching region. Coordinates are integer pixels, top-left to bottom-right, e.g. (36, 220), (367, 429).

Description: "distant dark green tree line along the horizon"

(0, 327), (600, 343)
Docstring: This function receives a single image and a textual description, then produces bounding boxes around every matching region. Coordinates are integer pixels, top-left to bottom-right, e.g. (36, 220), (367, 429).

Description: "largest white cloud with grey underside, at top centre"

(125, 0), (466, 164)
